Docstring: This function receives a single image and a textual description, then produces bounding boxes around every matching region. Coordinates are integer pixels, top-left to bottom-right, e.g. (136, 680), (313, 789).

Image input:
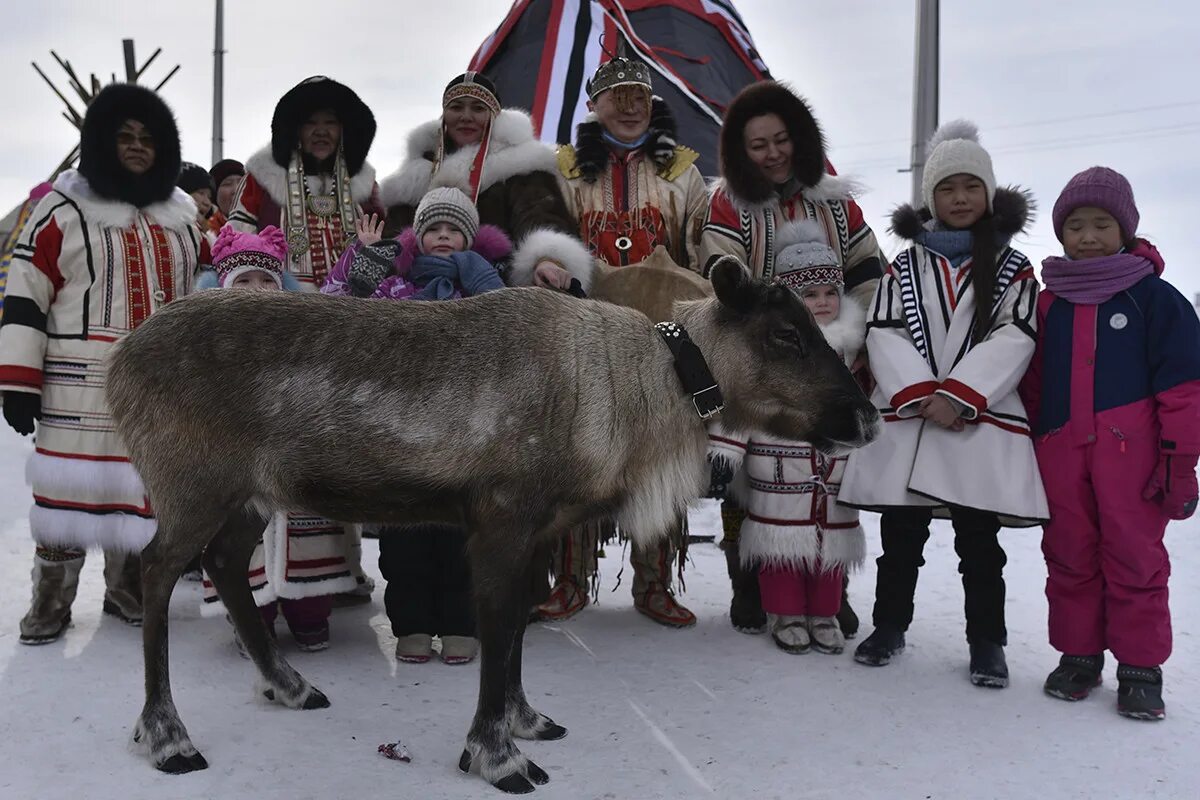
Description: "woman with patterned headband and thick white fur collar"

(379, 72), (592, 291)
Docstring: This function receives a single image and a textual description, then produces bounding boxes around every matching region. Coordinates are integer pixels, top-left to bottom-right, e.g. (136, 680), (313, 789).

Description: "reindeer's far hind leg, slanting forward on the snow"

(204, 512), (329, 709)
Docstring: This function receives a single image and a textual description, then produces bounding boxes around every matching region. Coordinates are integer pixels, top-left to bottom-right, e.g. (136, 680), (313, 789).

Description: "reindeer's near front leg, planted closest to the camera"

(458, 519), (550, 794)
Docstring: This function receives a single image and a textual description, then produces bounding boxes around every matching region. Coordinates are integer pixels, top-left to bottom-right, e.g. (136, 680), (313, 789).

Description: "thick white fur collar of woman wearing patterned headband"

(379, 108), (558, 209)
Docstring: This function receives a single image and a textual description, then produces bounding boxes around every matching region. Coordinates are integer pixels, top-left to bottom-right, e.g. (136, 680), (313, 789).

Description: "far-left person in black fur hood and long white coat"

(0, 84), (201, 644)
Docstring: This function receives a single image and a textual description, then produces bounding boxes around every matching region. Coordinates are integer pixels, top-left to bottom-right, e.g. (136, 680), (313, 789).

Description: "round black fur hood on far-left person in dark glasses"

(79, 83), (181, 209)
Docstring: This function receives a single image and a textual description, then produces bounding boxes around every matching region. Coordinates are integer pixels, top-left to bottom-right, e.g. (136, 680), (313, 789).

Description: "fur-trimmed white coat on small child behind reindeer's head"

(708, 295), (866, 570)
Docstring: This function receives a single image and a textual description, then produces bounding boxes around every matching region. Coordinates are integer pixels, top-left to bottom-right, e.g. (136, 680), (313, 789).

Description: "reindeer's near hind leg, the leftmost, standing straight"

(133, 503), (221, 774)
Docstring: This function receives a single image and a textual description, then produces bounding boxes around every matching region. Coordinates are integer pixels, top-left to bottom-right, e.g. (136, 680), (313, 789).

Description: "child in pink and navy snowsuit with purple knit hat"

(1021, 167), (1200, 720)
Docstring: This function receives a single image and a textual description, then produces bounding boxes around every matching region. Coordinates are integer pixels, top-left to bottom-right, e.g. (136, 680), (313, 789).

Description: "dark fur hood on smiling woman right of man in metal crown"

(720, 80), (826, 203)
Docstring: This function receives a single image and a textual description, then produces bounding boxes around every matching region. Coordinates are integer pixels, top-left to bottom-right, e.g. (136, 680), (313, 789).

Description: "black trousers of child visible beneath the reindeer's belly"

(379, 525), (475, 637)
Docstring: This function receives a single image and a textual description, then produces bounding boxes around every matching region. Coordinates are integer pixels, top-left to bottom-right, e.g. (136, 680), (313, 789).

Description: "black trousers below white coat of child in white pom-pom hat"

(874, 506), (1008, 644)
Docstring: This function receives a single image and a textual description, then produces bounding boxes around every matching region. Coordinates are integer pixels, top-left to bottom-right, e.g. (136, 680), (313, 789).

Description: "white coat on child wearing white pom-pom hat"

(839, 239), (1049, 527)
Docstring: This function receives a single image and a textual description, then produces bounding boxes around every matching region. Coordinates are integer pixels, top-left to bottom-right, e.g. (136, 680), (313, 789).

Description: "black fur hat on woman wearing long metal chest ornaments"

(271, 76), (376, 175)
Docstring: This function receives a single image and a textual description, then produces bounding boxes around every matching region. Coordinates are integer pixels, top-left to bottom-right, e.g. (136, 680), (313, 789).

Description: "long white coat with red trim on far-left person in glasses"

(0, 170), (202, 551)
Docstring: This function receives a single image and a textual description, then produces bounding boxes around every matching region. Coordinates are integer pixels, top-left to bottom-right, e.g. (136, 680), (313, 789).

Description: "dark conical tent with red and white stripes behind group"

(469, 0), (770, 176)
